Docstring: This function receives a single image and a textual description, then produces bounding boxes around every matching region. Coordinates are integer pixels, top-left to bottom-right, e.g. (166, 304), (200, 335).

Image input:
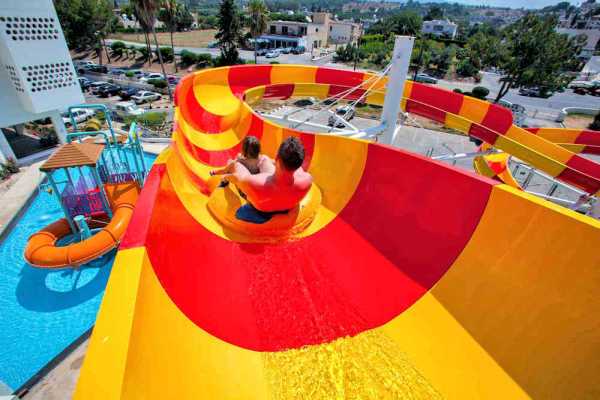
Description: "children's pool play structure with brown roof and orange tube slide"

(25, 105), (147, 268)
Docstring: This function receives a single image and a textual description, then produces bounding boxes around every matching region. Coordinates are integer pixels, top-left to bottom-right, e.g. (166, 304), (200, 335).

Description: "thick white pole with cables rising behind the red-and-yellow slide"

(381, 36), (415, 144)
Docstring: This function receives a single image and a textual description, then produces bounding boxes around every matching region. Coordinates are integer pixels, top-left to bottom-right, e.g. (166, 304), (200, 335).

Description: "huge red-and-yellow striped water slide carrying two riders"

(75, 65), (600, 400)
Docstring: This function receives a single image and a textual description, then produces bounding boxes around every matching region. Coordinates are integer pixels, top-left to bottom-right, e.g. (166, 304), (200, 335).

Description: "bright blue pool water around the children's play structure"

(0, 150), (156, 395)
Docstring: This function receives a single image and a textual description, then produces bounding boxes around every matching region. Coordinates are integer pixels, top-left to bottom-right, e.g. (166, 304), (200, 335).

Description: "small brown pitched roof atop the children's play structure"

(40, 143), (104, 172)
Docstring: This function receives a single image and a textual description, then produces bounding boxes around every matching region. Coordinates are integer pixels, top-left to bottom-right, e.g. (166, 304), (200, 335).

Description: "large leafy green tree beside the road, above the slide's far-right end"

(495, 14), (584, 102)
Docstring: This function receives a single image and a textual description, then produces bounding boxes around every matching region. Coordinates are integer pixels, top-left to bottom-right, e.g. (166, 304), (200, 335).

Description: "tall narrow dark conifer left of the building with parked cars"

(215, 0), (241, 65)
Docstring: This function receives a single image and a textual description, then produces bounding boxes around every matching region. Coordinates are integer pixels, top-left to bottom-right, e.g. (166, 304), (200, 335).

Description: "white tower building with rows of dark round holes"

(0, 0), (84, 163)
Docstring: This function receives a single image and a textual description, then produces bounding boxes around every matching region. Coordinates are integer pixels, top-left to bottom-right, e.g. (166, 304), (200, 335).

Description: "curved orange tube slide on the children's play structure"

(24, 183), (139, 268)
